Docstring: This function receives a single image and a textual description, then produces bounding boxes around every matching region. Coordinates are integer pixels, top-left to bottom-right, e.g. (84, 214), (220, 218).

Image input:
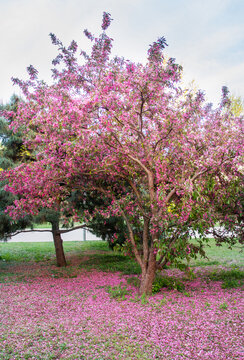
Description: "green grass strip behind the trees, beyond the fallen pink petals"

(0, 240), (243, 273)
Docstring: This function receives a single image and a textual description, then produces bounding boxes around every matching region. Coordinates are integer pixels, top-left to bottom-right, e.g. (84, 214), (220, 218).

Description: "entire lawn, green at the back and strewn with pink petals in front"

(0, 241), (244, 360)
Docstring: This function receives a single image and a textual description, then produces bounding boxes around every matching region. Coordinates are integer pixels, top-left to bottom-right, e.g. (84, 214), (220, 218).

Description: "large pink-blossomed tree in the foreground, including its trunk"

(0, 13), (243, 293)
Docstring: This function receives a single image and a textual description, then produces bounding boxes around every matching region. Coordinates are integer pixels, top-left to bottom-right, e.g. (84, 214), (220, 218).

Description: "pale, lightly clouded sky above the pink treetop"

(0, 0), (244, 105)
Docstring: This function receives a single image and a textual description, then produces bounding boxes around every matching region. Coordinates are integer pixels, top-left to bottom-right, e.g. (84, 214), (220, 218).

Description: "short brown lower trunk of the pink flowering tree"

(139, 248), (156, 295)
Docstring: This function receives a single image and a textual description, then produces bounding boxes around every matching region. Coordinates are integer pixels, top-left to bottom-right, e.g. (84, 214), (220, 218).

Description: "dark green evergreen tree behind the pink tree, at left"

(0, 95), (126, 266)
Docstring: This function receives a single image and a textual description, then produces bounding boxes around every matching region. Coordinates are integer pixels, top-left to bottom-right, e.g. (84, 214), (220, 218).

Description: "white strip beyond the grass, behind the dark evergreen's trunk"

(8, 229), (101, 242)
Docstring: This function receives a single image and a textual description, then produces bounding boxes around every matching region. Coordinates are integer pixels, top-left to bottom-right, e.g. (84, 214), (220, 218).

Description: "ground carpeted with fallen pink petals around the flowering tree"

(0, 271), (244, 360)
